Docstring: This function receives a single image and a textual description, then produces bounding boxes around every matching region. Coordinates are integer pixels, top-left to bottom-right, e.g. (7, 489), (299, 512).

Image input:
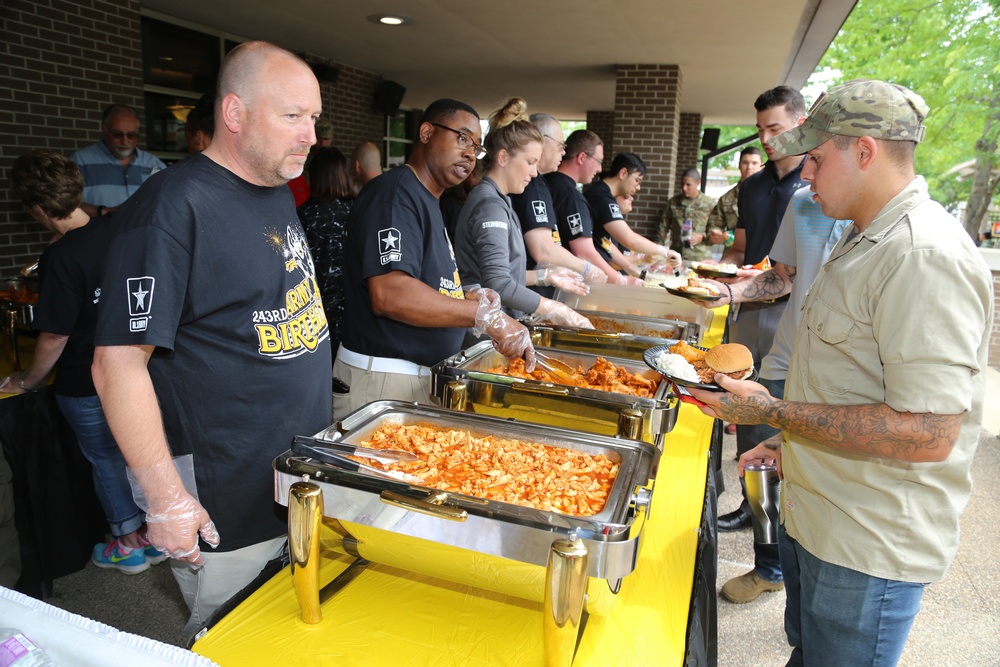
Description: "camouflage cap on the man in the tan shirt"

(767, 79), (930, 155)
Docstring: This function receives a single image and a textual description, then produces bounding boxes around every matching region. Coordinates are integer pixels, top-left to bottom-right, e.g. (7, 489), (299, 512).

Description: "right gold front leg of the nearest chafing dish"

(542, 537), (589, 667)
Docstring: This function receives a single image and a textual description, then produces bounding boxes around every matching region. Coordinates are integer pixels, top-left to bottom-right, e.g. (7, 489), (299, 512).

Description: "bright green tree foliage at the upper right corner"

(814, 0), (1000, 236)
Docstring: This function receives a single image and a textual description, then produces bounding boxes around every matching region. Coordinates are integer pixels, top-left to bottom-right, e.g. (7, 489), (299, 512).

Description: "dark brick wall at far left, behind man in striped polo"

(0, 0), (143, 276)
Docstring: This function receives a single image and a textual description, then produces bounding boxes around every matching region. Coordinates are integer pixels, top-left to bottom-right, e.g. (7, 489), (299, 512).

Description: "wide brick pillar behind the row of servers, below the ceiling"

(614, 65), (683, 238)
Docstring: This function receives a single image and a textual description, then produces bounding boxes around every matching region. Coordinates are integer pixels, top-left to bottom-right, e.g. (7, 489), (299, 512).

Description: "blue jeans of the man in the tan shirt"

(778, 526), (924, 667)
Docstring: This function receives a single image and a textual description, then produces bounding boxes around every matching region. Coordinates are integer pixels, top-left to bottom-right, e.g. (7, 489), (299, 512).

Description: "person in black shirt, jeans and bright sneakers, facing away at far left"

(0, 150), (167, 574)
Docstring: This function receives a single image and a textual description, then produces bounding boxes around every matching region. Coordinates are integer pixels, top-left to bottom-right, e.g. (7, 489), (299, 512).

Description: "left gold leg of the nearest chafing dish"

(288, 481), (323, 625)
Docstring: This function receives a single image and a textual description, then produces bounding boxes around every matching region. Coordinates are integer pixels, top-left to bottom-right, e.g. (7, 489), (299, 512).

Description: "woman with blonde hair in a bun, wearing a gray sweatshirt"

(455, 97), (593, 329)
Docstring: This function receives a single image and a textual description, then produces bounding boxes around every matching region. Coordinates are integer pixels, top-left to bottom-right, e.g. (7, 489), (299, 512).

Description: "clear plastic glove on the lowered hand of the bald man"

(128, 461), (220, 566)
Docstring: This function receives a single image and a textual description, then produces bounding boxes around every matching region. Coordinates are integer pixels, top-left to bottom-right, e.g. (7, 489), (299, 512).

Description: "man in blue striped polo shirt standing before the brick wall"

(69, 104), (167, 217)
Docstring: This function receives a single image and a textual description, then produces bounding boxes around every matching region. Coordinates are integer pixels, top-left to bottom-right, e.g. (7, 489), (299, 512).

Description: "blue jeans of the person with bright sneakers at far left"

(56, 394), (146, 537)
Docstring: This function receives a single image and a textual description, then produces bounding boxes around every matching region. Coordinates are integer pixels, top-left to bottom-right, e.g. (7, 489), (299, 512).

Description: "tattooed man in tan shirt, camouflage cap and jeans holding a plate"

(692, 81), (993, 665)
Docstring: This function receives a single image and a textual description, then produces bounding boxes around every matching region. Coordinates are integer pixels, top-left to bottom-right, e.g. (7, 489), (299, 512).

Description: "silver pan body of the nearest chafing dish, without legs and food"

(273, 401), (660, 579)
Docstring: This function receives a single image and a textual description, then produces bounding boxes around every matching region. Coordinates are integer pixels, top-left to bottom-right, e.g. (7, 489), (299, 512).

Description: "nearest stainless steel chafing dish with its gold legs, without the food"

(273, 401), (660, 664)
